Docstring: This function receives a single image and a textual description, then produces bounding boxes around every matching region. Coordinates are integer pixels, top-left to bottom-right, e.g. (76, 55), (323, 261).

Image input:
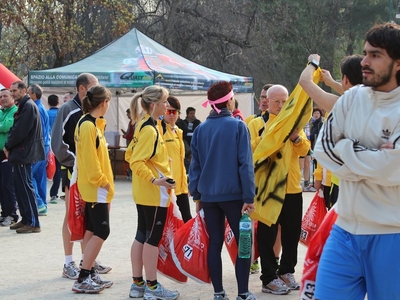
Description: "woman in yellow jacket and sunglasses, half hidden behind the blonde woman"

(159, 96), (192, 223)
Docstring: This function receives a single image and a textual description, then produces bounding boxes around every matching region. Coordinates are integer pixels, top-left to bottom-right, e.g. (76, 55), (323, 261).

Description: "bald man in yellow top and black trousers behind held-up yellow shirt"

(257, 84), (310, 295)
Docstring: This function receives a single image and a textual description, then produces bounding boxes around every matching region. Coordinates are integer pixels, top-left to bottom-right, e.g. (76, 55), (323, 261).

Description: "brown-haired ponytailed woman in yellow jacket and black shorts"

(72, 85), (114, 293)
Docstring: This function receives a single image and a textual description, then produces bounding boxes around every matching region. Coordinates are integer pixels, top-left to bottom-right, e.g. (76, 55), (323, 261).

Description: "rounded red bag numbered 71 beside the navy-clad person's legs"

(170, 210), (211, 283)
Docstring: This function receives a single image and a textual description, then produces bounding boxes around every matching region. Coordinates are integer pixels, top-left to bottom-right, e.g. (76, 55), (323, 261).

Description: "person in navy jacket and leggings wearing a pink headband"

(189, 81), (256, 300)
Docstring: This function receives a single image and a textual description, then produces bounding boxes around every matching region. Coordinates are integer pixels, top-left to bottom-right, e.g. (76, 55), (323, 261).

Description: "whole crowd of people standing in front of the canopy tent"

(0, 23), (400, 300)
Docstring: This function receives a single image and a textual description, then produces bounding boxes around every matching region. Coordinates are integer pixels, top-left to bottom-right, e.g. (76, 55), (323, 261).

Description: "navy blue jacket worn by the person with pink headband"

(189, 108), (255, 203)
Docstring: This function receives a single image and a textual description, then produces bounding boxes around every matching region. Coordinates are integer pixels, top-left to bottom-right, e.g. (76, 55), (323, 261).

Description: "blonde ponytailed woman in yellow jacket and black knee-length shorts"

(125, 85), (179, 300)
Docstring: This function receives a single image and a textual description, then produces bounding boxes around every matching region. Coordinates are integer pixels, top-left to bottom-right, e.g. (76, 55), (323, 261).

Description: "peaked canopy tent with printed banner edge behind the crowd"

(28, 29), (253, 136)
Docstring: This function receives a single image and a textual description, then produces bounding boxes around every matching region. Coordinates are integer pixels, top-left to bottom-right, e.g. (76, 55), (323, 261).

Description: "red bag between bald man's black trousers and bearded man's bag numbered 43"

(300, 190), (326, 246)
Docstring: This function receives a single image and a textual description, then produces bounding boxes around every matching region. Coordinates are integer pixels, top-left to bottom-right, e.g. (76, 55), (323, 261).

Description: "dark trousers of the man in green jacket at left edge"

(0, 162), (18, 222)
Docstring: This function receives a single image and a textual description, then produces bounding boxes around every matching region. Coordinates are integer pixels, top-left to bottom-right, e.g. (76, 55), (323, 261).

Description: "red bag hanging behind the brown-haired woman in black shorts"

(68, 166), (86, 242)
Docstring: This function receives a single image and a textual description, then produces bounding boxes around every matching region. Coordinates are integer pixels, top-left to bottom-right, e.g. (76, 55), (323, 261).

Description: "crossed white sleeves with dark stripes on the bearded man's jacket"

(314, 89), (400, 186)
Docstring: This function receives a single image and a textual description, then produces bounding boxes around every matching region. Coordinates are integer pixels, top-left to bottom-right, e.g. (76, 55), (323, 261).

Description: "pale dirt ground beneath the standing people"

(0, 177), (314, 300)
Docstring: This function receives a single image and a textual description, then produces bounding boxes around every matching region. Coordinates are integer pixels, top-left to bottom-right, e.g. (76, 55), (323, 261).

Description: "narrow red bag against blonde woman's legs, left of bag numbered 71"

(157, 195), (187, 283)
